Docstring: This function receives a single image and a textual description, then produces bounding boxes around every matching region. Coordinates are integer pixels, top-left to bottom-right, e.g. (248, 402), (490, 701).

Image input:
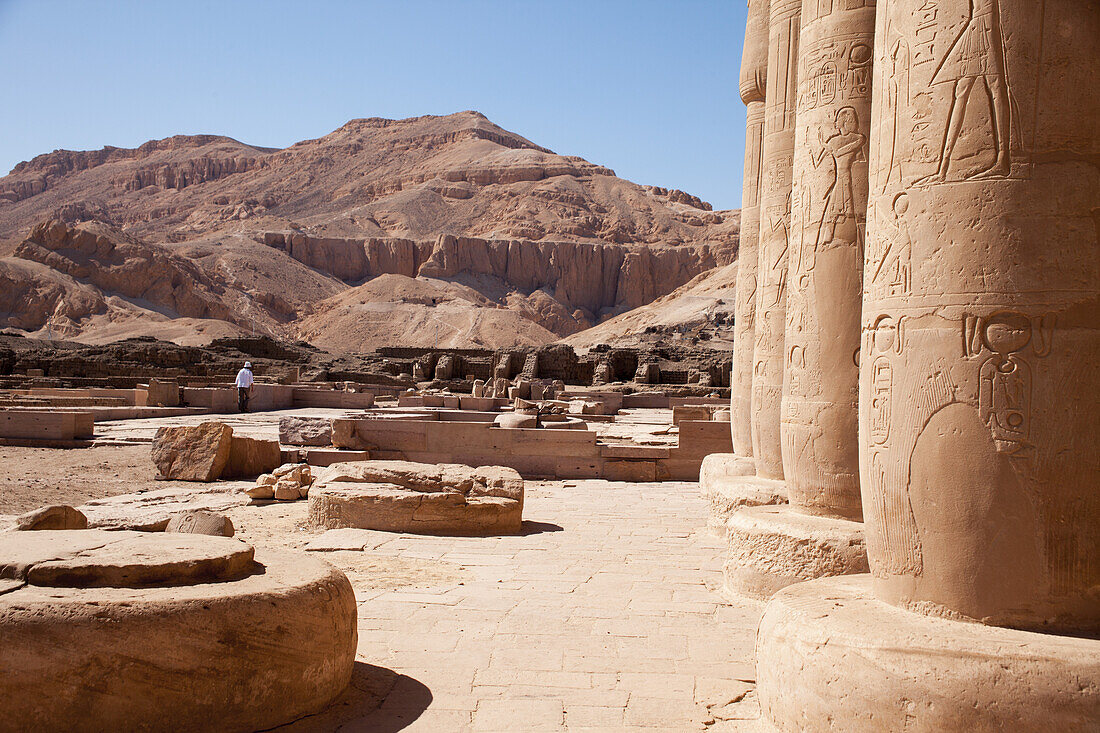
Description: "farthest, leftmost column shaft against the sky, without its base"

(729, 0), (768, 456)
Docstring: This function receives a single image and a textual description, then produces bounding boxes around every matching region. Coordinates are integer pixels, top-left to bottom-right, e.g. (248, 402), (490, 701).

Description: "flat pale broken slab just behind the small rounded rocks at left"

(77, 485), (249, 532)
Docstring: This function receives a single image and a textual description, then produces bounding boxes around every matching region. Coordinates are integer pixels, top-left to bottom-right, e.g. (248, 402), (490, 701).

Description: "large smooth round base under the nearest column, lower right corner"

(757, 575), (1100, 733)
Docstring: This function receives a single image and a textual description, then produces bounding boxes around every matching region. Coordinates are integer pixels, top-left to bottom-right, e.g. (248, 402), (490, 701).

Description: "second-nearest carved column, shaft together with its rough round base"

(725, 0), (875, 598)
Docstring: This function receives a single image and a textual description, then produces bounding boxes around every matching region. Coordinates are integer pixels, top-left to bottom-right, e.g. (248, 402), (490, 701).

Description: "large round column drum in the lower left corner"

(0, 530), (356, 731)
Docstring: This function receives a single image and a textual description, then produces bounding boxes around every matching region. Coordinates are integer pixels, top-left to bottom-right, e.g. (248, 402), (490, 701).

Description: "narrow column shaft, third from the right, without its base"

(752, 0), (802, 479)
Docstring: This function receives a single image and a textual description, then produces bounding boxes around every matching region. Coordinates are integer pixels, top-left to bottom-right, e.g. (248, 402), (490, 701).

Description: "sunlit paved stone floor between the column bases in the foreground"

(277, 481), (761, 732)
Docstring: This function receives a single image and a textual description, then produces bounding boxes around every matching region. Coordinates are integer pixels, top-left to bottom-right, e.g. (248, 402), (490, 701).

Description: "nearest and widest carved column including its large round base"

(758, 0), (1100, 731)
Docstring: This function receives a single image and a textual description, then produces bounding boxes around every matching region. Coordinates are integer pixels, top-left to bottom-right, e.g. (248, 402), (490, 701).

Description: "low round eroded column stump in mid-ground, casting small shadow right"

(309, 461), (524, 535)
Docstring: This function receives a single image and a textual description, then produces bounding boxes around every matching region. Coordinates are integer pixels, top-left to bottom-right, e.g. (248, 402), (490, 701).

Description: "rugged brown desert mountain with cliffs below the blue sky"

(0, 112), (739, 352)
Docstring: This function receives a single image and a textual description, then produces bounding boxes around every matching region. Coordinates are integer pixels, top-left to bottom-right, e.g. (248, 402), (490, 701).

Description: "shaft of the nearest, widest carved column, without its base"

(859, 0), (1100, 632)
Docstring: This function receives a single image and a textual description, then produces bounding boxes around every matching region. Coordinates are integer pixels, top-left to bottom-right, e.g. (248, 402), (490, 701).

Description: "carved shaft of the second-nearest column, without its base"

(780, 0), (875, 519)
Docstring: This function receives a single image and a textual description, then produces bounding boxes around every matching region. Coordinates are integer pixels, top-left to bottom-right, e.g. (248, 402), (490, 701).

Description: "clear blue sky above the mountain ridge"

(0, 0), (746, 208)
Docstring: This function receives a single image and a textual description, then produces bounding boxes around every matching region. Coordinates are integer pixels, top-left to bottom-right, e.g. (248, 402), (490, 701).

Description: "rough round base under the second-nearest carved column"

(724, 501), (868, 600)
